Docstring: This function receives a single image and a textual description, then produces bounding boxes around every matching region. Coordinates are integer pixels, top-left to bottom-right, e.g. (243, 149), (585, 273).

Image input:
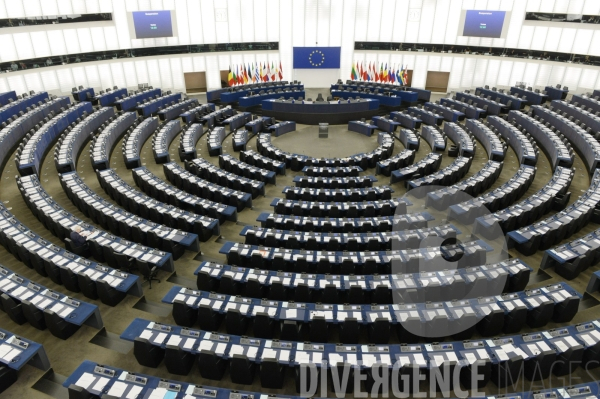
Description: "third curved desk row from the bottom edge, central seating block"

(162, 282), (581, 344)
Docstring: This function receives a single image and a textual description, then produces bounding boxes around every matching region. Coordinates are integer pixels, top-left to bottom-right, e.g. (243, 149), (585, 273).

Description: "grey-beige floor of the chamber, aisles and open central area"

(0, 89), (600, 399)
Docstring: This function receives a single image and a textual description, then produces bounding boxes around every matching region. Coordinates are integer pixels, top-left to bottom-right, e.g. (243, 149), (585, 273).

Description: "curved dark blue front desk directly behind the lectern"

(262, 99), (379, 125)
